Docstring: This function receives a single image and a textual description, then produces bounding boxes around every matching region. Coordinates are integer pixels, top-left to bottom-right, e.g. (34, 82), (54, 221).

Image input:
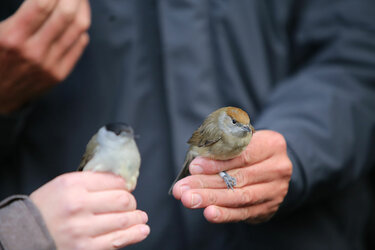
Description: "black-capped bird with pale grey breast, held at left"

(78, 123), (141, 191)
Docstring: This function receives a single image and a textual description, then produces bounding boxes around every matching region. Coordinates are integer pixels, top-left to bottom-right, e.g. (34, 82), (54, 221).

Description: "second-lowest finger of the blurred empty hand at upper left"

(46, 0), (91, 65)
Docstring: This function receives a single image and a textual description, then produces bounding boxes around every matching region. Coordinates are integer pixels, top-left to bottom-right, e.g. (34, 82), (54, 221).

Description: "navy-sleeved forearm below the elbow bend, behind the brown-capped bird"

(255, 41), (375, 213)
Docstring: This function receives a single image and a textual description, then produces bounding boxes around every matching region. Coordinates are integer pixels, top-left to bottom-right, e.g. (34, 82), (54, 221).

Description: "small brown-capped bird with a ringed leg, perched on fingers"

(168, 107), (255, 194)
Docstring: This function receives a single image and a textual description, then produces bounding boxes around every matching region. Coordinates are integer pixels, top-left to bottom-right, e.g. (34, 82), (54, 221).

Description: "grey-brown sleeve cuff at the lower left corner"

(0, 195), (56, 250)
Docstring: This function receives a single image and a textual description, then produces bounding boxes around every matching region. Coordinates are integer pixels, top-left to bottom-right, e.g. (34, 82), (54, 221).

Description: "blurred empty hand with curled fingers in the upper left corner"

(0, 0), (91, 114)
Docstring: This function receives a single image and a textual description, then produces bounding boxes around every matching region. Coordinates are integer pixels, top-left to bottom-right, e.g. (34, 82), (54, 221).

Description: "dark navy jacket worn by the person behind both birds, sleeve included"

(0, 0), (375, 250)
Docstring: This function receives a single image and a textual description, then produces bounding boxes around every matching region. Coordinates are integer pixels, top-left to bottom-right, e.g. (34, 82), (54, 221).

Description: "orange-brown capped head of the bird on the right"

(218, 107), (254, 137)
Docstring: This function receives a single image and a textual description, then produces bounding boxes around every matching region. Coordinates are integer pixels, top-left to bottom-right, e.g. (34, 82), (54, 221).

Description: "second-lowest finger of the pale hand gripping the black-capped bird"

(86, 210), (148, 237)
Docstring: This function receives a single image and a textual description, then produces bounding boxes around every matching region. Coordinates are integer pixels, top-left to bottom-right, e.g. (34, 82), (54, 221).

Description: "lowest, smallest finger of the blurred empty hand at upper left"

(56, 33), (89, 81)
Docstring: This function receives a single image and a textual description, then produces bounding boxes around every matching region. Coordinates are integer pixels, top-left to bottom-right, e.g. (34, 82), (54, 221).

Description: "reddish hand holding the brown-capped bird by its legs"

(173, 130), (292, 223)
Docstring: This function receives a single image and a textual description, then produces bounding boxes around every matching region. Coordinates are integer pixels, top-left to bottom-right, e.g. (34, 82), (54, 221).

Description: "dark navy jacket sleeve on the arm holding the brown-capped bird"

(256, 0), (375, 211)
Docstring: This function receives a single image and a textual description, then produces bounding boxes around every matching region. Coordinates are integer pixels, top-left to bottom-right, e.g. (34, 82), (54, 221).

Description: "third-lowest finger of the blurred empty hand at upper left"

(31, 0), (82, 51)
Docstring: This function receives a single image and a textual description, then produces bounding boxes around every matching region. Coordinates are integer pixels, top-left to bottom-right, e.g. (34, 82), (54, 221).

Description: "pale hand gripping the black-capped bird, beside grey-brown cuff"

(30, 171), (150, 250)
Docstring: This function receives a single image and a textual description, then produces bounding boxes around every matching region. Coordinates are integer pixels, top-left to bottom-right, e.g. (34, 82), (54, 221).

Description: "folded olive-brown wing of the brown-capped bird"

(188, 126), (222, 147)
